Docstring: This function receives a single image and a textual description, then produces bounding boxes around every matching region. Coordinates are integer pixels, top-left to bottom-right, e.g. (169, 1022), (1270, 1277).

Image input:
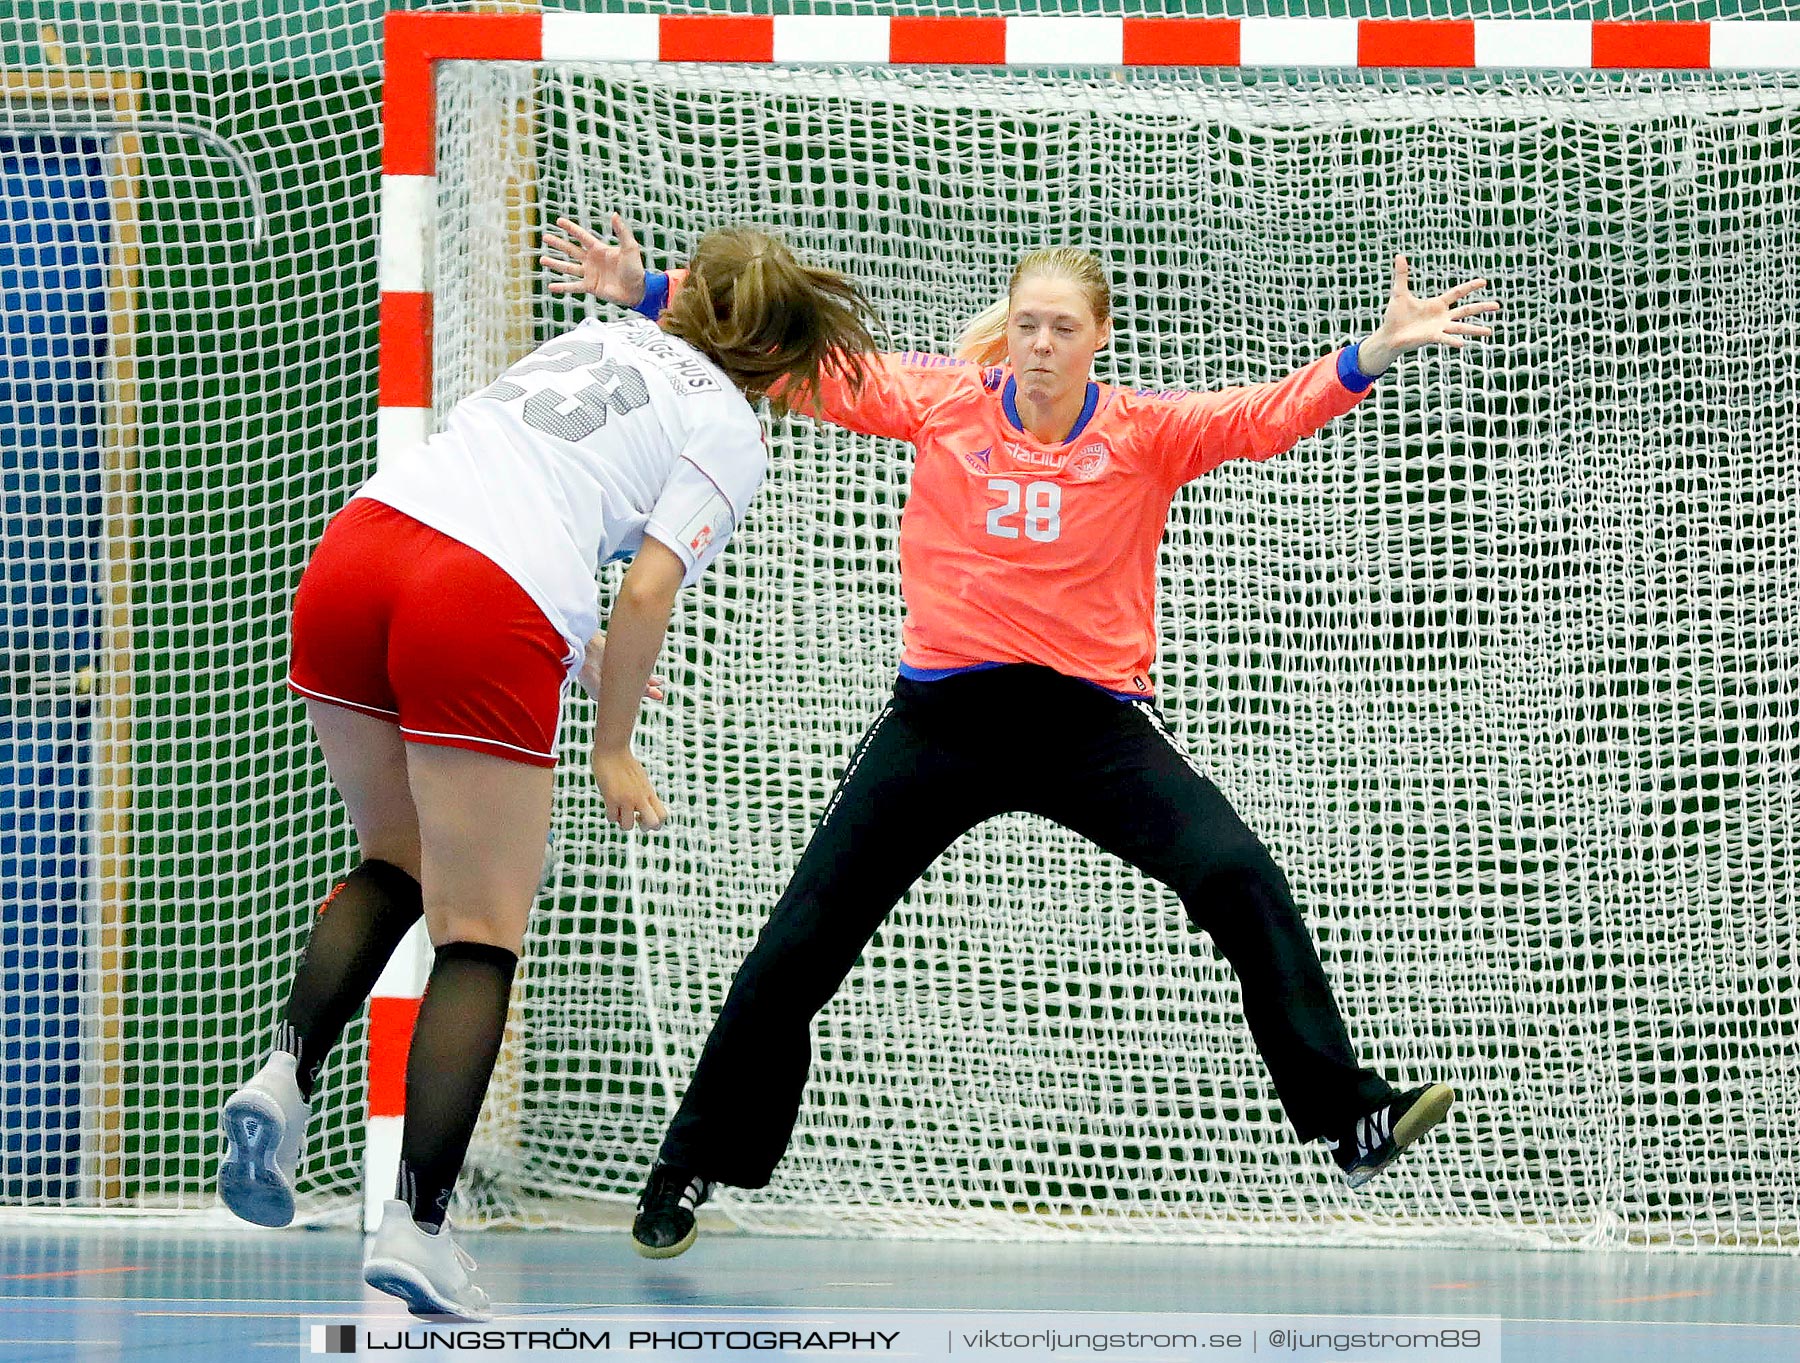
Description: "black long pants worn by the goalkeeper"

(662, 666), (1393, 1188)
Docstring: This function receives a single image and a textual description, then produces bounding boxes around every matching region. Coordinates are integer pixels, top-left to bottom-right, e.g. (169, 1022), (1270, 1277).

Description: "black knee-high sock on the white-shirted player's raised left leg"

(281, 861), (423, 1100)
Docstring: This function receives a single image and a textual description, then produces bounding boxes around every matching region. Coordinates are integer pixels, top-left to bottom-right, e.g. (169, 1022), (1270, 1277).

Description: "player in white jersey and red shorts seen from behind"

(220, 218), (873, 1320)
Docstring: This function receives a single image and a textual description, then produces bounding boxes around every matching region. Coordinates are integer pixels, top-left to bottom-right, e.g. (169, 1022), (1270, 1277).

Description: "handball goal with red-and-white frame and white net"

(367, 13), (1800, 1250)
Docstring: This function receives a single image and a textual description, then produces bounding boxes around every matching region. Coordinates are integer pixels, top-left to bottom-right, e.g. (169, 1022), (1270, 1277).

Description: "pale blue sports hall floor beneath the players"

(0, 1221), (1800, 1363)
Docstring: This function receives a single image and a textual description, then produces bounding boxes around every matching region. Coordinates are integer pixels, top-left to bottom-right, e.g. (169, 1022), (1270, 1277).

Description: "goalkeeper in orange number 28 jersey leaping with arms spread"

(550, 223), (1499, 1259)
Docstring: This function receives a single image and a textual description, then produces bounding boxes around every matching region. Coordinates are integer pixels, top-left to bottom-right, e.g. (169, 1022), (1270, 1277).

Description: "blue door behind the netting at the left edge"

(0, 137), (108, 1201)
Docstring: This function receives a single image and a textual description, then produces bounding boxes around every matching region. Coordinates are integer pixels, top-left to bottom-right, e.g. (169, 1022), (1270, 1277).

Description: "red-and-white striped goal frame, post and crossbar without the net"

(364, 2), (1800, 1228)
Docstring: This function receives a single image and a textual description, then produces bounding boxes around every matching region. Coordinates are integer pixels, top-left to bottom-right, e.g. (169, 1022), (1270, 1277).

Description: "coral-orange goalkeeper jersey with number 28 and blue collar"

(795, 351), (1366, 695)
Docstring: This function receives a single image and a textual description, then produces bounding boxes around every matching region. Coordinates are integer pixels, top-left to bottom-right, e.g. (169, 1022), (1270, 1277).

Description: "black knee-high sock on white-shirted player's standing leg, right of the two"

(394, 942), (518, 1230)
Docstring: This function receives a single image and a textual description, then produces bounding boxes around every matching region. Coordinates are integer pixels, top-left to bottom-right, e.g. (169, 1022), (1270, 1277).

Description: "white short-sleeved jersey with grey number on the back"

(356, 317), (769, 670)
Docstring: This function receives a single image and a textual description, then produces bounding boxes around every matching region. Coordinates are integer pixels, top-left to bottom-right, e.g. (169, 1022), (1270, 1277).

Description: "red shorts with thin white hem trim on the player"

(288, 497), (569, 767)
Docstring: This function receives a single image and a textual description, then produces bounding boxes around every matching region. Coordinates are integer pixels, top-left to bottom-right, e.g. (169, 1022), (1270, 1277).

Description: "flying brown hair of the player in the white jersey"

(662, 227), (875, 412)
